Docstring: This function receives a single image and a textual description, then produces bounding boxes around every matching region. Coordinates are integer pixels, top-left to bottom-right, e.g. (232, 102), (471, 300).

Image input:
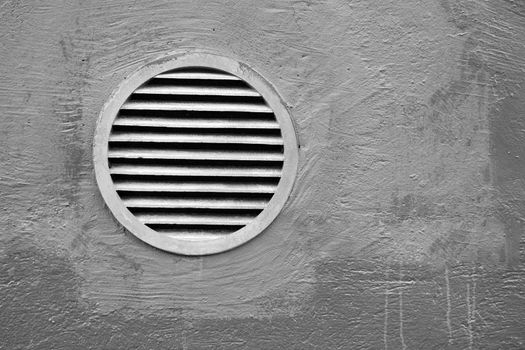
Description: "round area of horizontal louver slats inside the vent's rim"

(107, 67), (285, 241)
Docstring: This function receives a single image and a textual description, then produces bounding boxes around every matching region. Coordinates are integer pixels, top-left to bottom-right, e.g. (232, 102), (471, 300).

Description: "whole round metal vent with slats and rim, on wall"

(94, 53), (298, 255)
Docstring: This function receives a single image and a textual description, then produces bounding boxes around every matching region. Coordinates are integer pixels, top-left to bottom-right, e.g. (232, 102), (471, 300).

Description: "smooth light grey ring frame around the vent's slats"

(93, 51), (299, 256)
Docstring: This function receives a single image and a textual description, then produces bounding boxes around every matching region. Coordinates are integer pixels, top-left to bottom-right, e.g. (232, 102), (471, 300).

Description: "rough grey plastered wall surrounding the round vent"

(0, 0), (525, 349)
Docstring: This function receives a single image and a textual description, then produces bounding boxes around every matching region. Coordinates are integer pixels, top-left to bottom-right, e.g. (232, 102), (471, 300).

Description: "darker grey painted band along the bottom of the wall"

(0, 242), (525, 349)
